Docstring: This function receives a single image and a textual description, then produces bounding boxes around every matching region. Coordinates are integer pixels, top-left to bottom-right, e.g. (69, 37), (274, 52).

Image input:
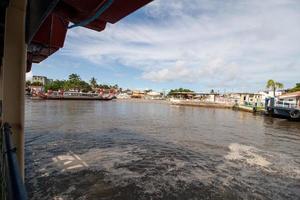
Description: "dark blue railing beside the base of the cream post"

(0, 123), (27, 200)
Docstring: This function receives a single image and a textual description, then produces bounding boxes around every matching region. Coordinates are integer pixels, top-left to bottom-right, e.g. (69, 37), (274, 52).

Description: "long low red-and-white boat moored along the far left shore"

(39, 91), (115, 101)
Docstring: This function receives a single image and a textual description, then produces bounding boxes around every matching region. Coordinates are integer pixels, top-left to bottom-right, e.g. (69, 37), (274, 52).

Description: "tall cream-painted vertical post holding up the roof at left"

(3, 0), (27, 180)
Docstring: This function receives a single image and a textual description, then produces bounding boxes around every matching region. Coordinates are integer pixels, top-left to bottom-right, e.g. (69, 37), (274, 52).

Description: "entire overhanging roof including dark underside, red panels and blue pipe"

(0, 0), (152, 72)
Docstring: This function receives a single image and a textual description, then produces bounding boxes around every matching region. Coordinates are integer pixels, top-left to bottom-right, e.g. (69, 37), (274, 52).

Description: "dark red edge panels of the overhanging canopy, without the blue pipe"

(27, 0), (152, 72)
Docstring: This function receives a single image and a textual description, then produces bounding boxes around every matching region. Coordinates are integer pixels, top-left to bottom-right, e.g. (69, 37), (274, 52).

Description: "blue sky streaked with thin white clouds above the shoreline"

(27, 0), (300, 92)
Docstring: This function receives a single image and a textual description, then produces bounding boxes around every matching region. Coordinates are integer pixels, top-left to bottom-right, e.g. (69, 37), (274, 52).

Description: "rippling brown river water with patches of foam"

(25, 100), (300, 200)
